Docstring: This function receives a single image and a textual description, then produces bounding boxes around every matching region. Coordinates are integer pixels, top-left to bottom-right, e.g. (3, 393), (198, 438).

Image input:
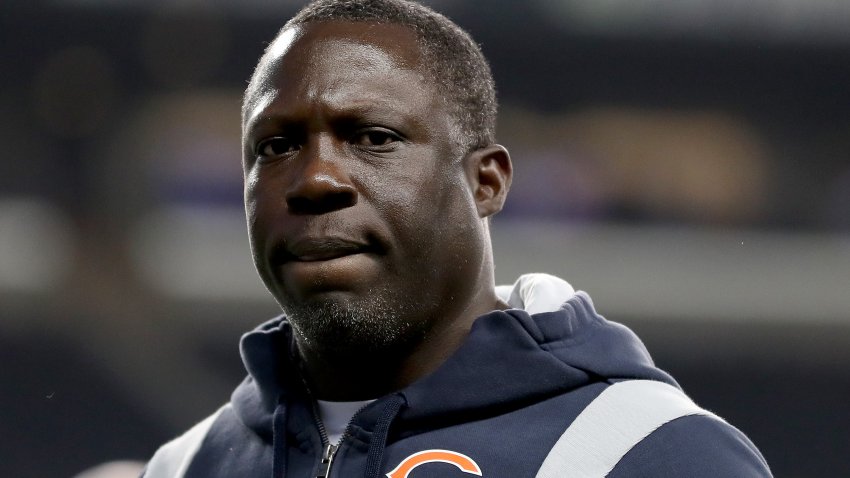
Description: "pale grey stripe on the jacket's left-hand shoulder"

(142, 403), (231, 478)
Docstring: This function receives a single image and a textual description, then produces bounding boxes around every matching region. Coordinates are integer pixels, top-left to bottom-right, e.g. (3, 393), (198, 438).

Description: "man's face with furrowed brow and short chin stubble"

(243, 22), (487, 352)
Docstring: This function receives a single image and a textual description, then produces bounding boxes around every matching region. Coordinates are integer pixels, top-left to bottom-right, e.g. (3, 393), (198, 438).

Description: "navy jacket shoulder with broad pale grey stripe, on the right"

(537, 380), (770, 478)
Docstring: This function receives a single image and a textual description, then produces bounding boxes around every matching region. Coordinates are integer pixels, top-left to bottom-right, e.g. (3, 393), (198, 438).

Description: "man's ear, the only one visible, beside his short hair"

(465, 144), (513, 218)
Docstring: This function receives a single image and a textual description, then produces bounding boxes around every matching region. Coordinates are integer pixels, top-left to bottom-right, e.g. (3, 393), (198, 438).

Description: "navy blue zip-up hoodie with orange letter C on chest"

(144, 292), (771, 478)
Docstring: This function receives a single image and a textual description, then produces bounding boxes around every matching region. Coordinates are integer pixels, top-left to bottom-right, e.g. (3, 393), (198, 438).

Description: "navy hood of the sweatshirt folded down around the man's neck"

(232, 277), (678, 439)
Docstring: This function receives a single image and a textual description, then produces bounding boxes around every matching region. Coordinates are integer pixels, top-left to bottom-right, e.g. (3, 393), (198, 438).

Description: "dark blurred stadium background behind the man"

(0, 0), (850, 477)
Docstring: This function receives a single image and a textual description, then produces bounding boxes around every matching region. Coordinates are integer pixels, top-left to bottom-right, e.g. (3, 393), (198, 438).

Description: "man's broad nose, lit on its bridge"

(286, 137), (357, 215)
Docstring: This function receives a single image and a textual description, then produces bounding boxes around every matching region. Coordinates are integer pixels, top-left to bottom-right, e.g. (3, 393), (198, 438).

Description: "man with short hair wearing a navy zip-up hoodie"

(145, 0), (770, 478)
